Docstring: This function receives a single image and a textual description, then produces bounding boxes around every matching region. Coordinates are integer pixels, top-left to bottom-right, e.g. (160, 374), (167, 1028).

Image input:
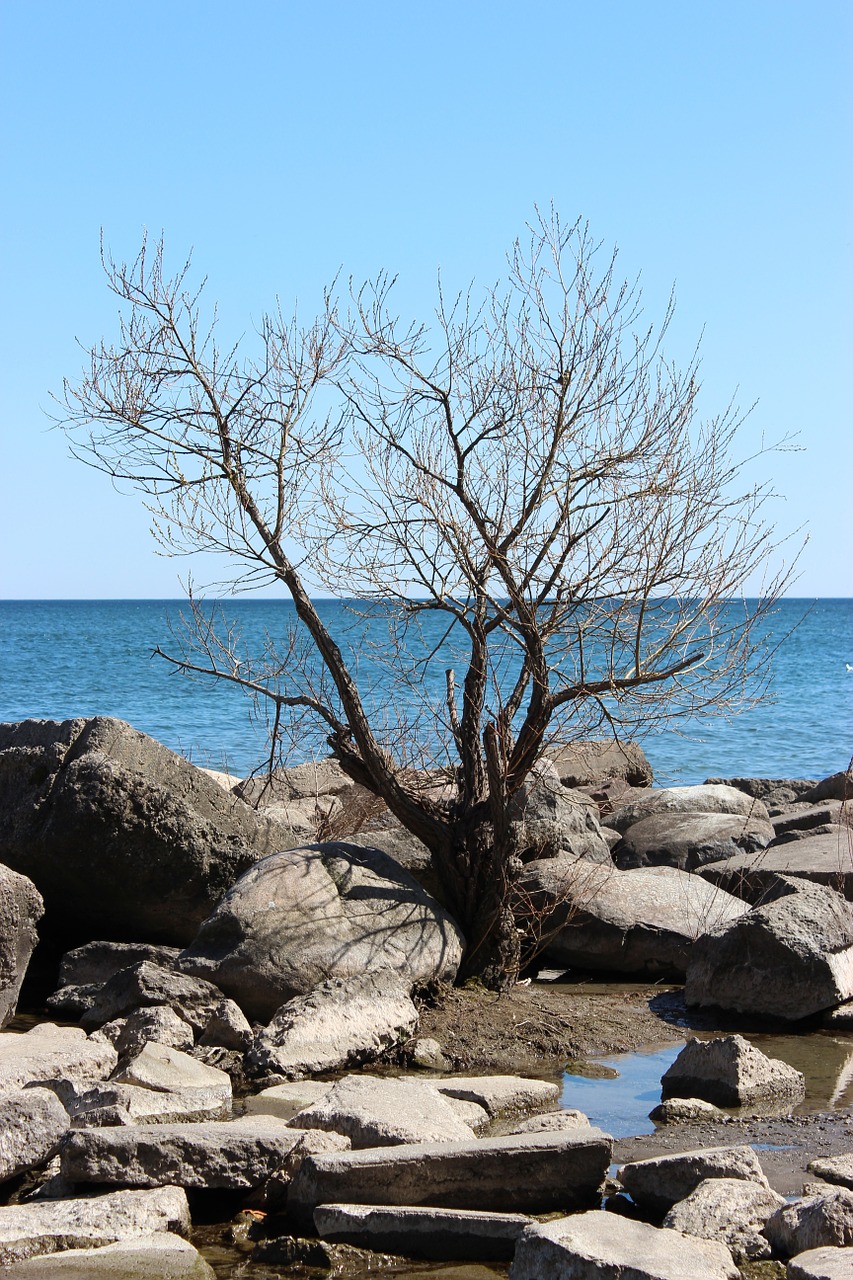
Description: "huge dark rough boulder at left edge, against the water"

(0, 717), (302, 945)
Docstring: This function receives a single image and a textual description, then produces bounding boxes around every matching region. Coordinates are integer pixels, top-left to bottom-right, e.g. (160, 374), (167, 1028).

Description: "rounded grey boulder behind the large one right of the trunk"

(613, 813), (774, 872)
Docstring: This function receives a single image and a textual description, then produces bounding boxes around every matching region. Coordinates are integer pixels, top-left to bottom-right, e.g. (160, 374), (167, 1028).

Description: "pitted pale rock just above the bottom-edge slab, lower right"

(663, 1178), (785, 1262)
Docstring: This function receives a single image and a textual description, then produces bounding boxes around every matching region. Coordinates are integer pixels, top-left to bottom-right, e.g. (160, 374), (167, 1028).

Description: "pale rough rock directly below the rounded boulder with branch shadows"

(248, 973), (418, 1076)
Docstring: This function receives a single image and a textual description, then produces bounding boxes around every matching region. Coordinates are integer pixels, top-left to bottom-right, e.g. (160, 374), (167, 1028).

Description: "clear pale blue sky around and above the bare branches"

(0, 0), (853, 598)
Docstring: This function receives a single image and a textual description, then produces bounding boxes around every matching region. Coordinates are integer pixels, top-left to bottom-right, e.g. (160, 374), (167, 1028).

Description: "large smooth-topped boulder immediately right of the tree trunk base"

(523, 858), (747, 977)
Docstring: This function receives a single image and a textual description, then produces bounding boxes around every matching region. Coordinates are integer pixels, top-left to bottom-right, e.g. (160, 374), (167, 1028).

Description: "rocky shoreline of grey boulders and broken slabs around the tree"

(0, 718), (853, 1280)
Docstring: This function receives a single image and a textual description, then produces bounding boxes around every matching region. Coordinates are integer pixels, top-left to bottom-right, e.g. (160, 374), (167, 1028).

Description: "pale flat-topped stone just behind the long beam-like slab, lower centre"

(288, 1075), (474, 1149)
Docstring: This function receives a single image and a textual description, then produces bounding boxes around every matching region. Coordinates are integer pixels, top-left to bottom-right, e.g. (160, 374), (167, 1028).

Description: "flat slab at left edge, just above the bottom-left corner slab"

(0, 1187), (190, 1267)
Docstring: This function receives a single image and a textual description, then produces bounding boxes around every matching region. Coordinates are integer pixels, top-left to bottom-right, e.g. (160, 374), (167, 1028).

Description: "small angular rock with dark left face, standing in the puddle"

(661, 1036), (806, 1107)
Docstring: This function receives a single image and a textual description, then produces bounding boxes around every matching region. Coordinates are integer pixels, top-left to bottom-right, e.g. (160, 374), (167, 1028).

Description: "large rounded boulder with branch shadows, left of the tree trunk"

(178, 841), (462, 1021)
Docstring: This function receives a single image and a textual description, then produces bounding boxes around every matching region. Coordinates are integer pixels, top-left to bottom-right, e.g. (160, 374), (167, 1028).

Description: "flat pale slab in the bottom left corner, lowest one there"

(3, 1231), (215, 1280)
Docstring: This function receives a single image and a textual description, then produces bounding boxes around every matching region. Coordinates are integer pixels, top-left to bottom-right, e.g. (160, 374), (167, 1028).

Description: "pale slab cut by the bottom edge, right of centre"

(510, 1210), (740, 1280)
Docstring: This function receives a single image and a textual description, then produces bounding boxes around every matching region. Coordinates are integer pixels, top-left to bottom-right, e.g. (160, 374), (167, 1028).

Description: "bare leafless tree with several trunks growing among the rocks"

(63, 214), (799, 987)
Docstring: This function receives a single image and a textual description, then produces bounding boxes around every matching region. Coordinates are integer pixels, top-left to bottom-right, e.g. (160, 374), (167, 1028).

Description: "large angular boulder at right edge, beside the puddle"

(685, 880), (853, 1021)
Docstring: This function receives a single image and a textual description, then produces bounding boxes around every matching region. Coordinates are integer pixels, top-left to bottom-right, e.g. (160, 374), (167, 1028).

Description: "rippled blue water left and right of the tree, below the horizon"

(0, 599), (853, 783)
